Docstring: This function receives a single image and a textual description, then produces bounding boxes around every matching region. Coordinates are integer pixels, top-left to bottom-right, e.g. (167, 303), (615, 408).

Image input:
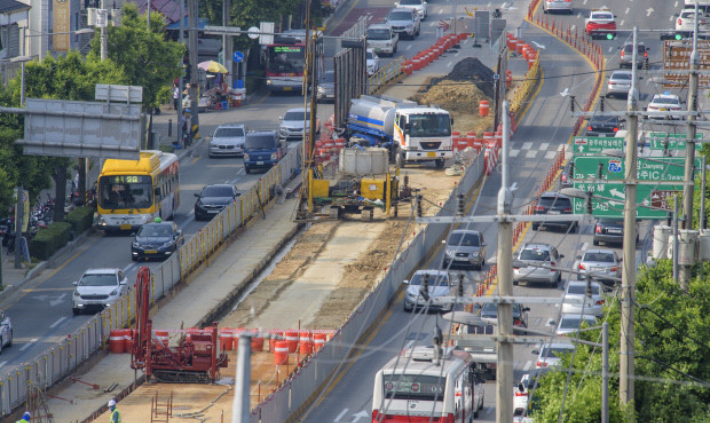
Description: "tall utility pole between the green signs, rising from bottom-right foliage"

(619, 27), (638, 405)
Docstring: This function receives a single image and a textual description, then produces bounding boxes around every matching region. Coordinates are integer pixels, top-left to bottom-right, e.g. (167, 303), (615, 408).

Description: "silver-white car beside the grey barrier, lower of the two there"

(402, 269), (453, 311)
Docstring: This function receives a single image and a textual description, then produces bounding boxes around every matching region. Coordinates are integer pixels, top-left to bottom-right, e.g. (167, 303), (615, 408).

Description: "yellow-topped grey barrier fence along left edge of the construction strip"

(0, 147), (301, 416)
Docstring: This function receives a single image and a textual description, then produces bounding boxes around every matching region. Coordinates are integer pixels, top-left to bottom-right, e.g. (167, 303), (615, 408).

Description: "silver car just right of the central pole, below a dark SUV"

(513, 243), (564, 287)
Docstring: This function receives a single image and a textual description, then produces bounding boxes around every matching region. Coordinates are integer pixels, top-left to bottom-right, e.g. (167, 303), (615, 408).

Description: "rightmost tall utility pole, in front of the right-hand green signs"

(673, 2), (702, 291)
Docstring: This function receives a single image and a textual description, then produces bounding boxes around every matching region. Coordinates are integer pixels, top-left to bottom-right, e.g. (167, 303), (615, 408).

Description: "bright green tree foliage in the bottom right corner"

(532, 260), (710, 422)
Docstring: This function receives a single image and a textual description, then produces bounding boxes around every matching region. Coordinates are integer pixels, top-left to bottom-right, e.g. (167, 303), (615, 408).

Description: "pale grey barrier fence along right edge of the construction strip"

(250, 154), (484, 423)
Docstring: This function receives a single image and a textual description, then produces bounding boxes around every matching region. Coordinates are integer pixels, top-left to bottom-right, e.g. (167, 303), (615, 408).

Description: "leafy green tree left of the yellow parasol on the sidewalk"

(89, 3), (185, 110)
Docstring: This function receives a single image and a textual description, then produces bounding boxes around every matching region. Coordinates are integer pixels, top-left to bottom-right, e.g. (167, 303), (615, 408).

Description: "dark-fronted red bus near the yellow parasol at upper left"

(265, 40), (306, 91)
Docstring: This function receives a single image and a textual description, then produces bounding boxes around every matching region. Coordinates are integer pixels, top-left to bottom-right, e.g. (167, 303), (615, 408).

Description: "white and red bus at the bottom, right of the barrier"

(372, 347), (484, 423)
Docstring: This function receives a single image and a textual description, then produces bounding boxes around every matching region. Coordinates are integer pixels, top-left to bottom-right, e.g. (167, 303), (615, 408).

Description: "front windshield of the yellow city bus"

(99, 175), (153, 210)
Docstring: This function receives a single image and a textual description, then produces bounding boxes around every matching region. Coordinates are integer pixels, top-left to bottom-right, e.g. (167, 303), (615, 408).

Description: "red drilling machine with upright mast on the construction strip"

(131, 267), (229, 383)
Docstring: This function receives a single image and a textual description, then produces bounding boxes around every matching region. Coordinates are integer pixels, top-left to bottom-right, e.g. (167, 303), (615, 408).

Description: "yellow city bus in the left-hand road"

(96, 150), (180, 232)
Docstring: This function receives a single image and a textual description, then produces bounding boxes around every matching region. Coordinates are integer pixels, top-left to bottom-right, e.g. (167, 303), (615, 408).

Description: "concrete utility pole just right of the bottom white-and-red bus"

(496, 101), (514, 423)
